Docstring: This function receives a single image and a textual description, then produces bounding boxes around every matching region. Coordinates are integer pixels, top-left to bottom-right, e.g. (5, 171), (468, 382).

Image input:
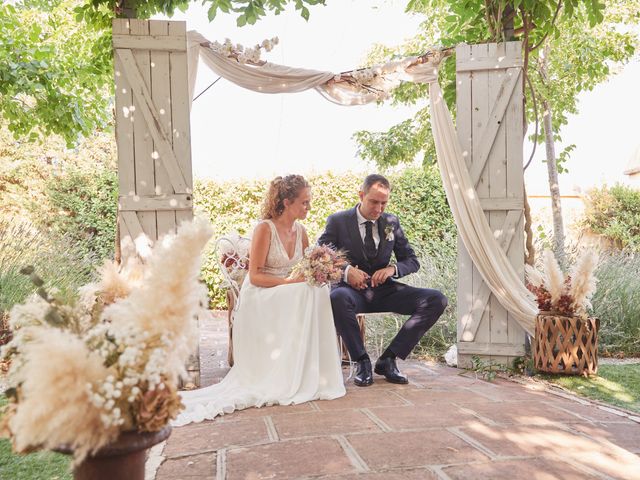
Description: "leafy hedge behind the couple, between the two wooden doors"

(194, 167), (456, 308)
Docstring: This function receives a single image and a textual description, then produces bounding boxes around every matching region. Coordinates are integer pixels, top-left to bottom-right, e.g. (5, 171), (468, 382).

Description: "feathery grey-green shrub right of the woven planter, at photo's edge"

(591, 250), (640, 356)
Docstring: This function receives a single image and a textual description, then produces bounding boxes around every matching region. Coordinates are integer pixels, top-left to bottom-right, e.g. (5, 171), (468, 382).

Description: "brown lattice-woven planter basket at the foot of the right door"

(533, 312), (600, 375)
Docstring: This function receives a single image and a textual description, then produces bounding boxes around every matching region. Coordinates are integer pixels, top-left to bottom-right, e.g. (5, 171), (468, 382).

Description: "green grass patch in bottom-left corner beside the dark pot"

(0, 395), (72, 480)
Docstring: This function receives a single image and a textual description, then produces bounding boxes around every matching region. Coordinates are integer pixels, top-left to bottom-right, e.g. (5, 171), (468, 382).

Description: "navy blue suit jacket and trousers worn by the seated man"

(318, 206), (447, 359)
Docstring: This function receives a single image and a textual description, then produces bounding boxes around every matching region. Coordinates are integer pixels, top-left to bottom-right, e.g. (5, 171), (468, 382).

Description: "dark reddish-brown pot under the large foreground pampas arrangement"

(58, 425), (171, 480)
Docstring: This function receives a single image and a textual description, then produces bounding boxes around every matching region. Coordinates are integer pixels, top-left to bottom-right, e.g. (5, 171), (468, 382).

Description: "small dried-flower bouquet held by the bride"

(291, 245), (347, 287)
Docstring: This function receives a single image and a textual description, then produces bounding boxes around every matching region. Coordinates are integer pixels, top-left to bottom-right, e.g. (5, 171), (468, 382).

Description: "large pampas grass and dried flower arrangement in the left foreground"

(0, 220), (212, 462)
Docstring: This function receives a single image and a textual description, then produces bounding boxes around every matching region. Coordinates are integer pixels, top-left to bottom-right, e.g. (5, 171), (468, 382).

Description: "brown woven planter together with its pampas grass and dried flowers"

(526, 250), (600, 375)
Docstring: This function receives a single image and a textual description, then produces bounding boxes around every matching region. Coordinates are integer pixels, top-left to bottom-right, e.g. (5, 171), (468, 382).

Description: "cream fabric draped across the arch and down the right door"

(187, 32), (538, 335)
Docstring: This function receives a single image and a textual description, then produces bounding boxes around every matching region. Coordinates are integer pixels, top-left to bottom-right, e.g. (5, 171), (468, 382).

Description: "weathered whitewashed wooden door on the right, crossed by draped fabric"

(456, 42), (525, 366)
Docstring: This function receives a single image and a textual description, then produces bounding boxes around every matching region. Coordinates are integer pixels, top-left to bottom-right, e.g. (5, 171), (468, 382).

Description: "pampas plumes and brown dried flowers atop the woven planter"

(525, 250), (598, 317)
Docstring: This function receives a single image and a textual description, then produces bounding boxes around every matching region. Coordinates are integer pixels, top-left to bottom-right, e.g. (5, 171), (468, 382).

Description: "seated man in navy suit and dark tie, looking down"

(318, 175), (447, 387)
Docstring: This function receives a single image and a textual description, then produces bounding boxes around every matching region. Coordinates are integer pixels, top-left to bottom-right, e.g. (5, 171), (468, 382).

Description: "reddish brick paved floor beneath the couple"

(147, 316), (640, 480)
